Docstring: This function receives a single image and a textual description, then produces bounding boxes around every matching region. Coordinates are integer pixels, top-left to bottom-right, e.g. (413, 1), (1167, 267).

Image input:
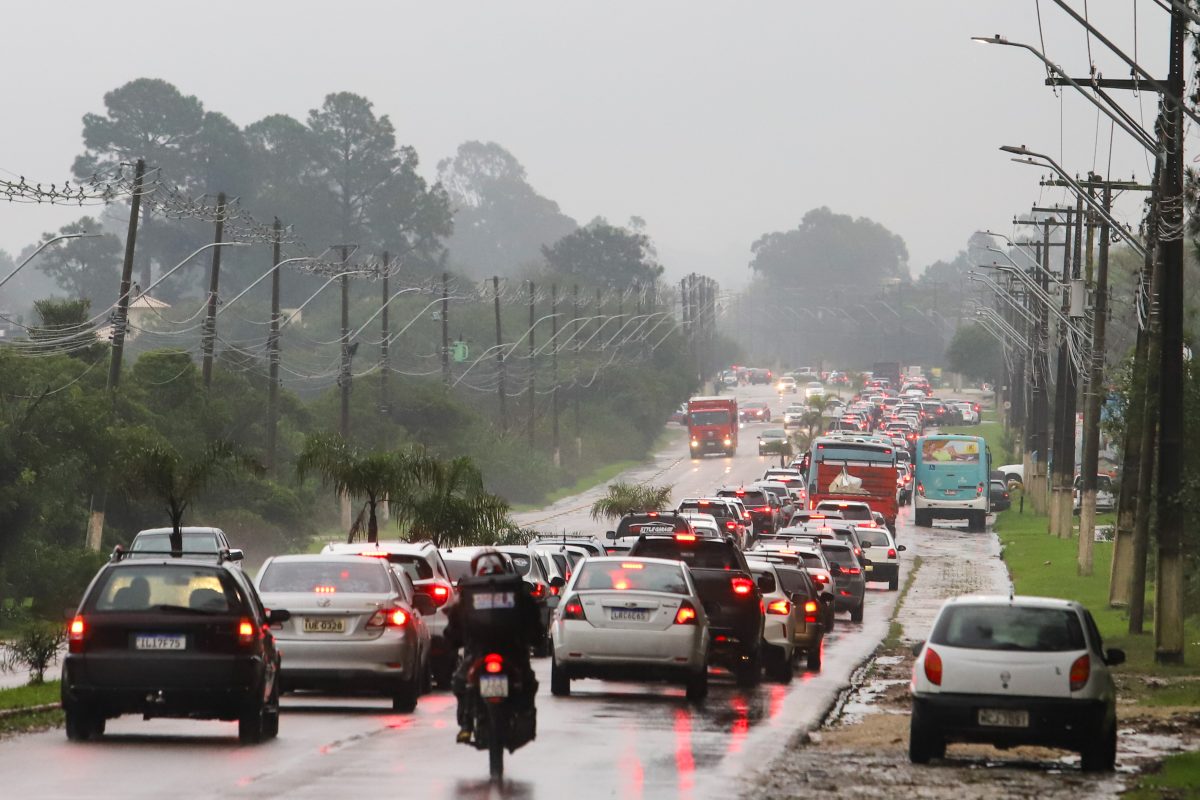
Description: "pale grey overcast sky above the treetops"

(0, 0), (1180, 285)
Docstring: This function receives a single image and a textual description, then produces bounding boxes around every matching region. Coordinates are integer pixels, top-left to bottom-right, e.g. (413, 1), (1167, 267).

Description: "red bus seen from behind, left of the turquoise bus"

(809, 437), (900, 533)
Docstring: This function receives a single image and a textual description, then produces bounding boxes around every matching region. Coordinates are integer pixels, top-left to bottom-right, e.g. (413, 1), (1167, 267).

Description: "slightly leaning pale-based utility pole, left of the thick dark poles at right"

(1079, 184), (1112, 576)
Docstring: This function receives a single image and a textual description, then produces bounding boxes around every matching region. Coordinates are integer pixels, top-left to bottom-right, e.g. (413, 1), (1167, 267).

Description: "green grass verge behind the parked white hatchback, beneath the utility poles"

(996, 509), (1200, 676)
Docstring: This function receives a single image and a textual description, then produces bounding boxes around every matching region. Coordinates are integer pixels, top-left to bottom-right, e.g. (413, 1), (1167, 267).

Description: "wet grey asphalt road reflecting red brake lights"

(0, 387), (914, 800)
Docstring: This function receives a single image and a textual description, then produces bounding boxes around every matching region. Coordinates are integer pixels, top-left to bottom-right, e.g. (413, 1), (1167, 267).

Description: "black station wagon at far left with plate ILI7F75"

(62, 551), (290, 744)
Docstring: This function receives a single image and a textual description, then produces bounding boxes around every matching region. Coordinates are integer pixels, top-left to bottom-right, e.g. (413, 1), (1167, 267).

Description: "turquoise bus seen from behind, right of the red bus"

(913, 434), (991, 531)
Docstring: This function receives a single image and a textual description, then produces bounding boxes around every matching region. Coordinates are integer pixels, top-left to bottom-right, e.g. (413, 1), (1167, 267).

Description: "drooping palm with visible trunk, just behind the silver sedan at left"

(296, 433), (433, 543)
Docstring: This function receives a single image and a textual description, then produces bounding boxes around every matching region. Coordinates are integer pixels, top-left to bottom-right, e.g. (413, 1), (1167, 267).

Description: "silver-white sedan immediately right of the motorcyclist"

(550, 557), (709, 702)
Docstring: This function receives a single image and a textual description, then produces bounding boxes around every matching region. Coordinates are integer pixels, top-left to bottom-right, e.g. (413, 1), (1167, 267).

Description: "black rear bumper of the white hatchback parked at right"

(912, 694), (1116, 750)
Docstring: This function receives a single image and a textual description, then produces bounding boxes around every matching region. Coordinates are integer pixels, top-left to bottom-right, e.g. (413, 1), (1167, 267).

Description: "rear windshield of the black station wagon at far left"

(91, 564), (234, 614)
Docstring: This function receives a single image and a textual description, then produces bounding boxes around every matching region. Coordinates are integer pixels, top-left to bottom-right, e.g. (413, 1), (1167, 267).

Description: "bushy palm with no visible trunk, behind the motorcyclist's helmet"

(390, 456), (512, 547)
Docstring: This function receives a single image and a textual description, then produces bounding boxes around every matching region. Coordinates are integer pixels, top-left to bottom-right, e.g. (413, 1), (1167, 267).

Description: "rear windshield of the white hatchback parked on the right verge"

(930, 604), (1087, 652)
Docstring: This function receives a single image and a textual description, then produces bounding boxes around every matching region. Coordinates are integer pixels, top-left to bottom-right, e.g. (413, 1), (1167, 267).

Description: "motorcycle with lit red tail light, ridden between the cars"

(467, 652), (538, 781)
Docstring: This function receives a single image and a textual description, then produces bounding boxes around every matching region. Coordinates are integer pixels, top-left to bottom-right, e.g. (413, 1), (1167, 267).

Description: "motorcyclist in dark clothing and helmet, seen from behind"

(445, 547), (546, 742)
